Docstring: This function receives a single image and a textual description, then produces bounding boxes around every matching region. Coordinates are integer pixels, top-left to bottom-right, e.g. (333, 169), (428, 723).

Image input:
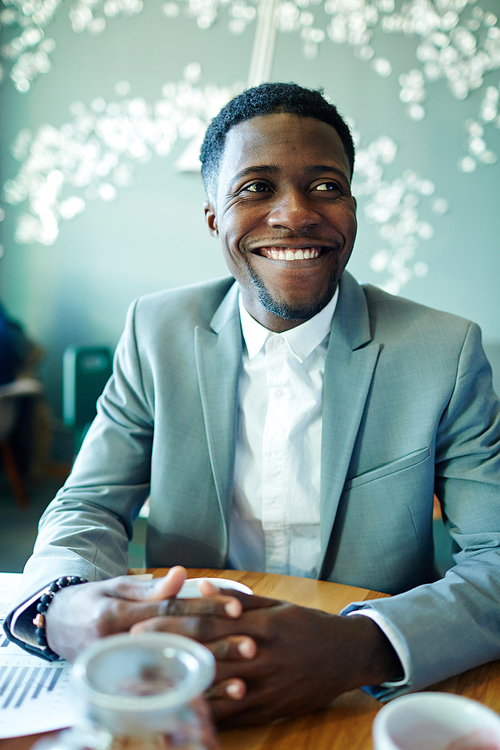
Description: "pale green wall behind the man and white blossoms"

(0, 0), (500, 428)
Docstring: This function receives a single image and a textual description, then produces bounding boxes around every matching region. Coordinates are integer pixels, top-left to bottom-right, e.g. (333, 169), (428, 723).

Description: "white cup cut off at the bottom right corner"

(372, 692), (500, 750)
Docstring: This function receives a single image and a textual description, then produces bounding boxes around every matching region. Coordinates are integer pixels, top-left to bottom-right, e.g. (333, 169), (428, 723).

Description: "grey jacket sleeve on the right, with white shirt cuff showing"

(343, 324), (500, 698)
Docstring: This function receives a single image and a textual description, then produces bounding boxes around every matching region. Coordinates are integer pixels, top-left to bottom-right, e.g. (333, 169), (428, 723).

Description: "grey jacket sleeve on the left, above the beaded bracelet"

(9, 296), (153, 602)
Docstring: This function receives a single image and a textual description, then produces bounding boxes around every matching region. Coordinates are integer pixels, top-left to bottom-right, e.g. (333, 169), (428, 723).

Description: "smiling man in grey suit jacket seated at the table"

(3, 84), (500, 723)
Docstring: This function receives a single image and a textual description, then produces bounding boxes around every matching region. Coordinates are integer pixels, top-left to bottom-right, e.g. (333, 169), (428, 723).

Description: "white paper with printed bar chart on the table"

(0, 573), (80, 739)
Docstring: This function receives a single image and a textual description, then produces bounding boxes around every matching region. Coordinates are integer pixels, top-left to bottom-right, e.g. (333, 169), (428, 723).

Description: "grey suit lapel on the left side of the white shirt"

(195, 284), (242, 519)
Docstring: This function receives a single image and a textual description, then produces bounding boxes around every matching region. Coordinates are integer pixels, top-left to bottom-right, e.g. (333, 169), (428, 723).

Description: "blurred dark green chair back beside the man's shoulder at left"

(63, 346), (113, 455)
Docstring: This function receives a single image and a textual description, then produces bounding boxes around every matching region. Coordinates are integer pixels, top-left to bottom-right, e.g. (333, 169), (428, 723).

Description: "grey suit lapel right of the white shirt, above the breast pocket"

(321, 272), (380, 558)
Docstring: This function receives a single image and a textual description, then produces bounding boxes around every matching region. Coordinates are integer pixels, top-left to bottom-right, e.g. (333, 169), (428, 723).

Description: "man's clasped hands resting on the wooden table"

(47, 566), (397, 725)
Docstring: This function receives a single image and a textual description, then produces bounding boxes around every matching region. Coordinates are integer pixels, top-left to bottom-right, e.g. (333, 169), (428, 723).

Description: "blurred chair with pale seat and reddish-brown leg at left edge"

(0, 378), (42, 508)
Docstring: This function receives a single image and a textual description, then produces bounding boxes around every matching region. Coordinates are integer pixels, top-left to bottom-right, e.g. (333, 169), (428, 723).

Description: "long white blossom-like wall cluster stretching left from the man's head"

(3, 63), (243, 245)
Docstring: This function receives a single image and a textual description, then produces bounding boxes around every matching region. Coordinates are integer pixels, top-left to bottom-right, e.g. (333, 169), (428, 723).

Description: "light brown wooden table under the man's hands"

(0, 569), (500, 750)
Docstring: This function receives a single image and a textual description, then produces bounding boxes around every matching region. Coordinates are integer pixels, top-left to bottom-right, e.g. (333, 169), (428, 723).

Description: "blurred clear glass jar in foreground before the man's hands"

(32, 633), (216, 750)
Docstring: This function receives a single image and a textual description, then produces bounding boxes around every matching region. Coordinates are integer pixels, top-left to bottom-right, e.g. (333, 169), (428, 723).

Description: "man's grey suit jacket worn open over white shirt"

(13, 273), (500, 700)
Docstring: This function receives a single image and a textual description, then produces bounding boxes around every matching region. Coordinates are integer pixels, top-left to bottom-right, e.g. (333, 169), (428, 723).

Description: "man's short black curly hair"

(200, 83), (354, 197)
